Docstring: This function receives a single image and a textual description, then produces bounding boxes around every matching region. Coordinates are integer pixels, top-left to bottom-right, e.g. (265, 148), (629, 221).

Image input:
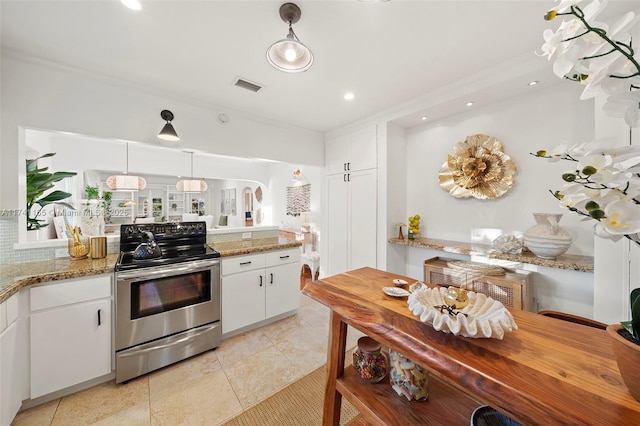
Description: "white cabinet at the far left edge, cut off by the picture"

(0, 294), (24, 425)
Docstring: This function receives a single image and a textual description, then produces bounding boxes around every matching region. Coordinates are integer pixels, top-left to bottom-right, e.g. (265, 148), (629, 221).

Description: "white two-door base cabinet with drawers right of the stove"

(222, 248), (300, 334)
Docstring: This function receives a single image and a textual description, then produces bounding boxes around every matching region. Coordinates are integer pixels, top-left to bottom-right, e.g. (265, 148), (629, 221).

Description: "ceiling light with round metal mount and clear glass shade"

(267, 3), (313, 73)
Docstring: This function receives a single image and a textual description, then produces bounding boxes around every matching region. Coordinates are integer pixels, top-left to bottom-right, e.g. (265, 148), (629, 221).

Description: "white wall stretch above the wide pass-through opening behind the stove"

(0, 51), (324, 208)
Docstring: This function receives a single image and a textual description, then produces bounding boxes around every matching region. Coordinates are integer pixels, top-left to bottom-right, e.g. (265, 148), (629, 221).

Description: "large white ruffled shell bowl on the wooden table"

(408, 286), (518, 340)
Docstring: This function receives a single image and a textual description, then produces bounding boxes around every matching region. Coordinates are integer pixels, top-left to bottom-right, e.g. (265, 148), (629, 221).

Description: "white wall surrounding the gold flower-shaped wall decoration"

(398, 82), (594, 256)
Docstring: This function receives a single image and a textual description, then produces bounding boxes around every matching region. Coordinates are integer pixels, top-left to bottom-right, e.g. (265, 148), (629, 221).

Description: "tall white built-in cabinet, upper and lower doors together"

(325, 128), (378, 275)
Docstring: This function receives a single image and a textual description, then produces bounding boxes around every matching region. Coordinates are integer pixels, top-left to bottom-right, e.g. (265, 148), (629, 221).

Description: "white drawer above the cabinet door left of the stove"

(29, 275), (111, 311)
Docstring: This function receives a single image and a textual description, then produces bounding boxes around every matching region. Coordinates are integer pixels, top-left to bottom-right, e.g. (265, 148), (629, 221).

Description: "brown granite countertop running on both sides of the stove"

(0, 237), (302, 303)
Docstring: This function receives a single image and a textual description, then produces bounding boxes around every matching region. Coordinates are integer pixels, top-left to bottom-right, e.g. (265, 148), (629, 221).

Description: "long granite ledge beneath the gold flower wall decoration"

(388, 238), (593, 272)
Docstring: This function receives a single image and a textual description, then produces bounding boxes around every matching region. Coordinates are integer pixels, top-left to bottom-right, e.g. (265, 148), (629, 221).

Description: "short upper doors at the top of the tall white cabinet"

(325, 127), (378, 175)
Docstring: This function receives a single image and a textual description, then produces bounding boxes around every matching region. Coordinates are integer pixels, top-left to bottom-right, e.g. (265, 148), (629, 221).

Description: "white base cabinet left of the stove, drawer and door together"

(29, 275), (112, 398)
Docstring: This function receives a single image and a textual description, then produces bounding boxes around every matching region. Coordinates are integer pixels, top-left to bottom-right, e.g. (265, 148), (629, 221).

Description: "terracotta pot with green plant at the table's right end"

(607, 288), (640, 401)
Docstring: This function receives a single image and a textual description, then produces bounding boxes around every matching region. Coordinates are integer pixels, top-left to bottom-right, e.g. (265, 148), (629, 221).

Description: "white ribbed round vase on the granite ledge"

(524, 213), (571, 259)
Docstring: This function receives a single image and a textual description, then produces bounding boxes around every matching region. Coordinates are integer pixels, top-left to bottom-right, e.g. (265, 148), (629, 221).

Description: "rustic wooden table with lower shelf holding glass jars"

(303, 268), (640, 426)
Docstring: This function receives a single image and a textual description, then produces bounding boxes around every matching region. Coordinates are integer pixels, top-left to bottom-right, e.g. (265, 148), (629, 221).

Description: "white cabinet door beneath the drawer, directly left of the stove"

(31, 299), (111, 398)
